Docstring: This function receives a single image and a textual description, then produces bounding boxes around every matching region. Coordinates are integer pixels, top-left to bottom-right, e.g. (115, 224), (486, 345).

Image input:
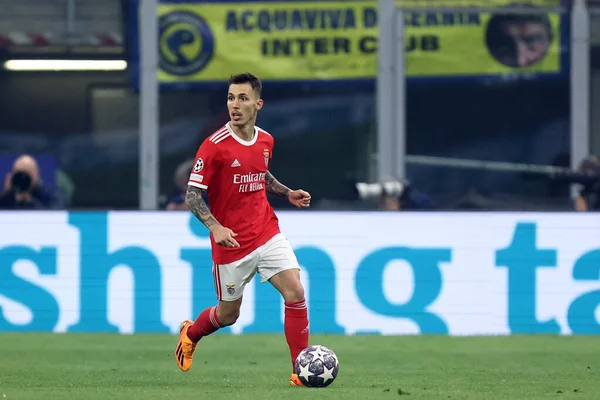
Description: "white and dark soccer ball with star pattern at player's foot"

(294, 345), (340, 388)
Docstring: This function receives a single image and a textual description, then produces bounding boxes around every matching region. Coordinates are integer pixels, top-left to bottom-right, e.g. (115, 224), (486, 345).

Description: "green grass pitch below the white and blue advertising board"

(0, 333), (600, 400)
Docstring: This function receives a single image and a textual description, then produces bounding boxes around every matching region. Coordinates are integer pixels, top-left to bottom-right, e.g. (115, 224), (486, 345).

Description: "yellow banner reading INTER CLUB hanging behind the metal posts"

(158, 0), (560, 82)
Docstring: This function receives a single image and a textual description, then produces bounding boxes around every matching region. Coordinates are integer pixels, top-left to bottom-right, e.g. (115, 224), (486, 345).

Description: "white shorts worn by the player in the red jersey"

(213, 233), (300, 301)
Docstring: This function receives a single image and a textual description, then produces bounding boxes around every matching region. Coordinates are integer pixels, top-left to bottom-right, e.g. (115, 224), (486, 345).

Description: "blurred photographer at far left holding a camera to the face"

(0, 155), (64, 210)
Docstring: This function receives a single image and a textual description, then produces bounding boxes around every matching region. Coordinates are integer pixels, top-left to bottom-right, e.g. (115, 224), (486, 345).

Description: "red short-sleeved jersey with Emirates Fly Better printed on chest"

(188, 123), (279, 264)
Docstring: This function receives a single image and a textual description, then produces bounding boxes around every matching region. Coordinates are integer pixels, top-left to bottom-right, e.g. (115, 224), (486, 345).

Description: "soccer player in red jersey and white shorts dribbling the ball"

(175, 73), (311, 386)
